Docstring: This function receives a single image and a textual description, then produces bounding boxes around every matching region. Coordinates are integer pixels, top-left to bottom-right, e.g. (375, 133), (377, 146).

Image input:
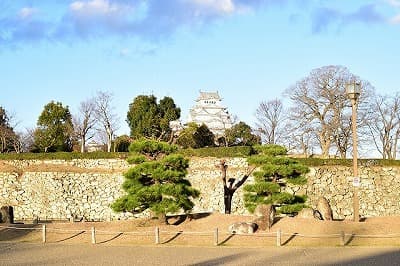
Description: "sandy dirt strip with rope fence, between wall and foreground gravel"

(0, 213), (400, 247)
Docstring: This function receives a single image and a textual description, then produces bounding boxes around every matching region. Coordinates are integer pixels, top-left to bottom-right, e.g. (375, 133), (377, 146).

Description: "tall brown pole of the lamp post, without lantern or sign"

(351, 99), (360, 222)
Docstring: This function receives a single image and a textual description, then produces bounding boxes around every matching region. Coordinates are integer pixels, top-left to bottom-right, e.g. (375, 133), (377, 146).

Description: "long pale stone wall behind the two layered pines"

(0, 158), (400, 220)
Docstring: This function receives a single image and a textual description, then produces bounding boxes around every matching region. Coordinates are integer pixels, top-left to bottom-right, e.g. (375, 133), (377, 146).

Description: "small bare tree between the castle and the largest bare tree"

(256, 99), (285, 144)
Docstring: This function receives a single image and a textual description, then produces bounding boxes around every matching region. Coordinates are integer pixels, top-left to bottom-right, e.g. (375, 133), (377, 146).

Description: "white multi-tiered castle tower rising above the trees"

(187, 91), (232, 137)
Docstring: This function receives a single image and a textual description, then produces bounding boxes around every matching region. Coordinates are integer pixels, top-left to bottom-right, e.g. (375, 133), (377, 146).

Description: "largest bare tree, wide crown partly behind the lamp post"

(286, 66), (372, 158)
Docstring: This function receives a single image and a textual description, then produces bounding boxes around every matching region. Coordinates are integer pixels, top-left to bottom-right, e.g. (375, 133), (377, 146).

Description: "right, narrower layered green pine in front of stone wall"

(244, 144), (309, 213)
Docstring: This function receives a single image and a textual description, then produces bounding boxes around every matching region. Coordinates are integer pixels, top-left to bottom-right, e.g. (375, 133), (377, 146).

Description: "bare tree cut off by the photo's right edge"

(366, 93), (400, 159)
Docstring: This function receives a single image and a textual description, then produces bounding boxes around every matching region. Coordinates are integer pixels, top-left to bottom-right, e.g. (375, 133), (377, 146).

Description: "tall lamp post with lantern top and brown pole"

(346, 82), (361, 222)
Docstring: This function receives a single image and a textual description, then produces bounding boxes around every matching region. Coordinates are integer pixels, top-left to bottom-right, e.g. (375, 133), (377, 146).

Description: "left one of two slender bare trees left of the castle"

(73, 98), (96, 152)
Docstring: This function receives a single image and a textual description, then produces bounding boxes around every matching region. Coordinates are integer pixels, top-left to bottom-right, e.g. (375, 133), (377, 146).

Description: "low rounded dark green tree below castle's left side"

(176, 123), (214, 149)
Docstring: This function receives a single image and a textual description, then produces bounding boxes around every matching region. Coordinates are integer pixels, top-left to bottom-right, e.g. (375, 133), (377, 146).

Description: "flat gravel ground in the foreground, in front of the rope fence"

(0, 242), (400, 266)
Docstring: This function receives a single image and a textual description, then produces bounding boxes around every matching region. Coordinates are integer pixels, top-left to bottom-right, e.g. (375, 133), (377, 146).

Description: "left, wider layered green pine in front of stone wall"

(111, 139), (200, 222)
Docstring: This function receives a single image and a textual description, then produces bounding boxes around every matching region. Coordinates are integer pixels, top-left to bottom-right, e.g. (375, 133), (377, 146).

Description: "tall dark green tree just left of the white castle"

(126, 95), (181, 140)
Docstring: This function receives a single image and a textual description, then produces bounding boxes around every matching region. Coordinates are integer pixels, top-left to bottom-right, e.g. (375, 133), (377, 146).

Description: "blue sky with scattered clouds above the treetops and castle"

(0, 0), (400, 134)
